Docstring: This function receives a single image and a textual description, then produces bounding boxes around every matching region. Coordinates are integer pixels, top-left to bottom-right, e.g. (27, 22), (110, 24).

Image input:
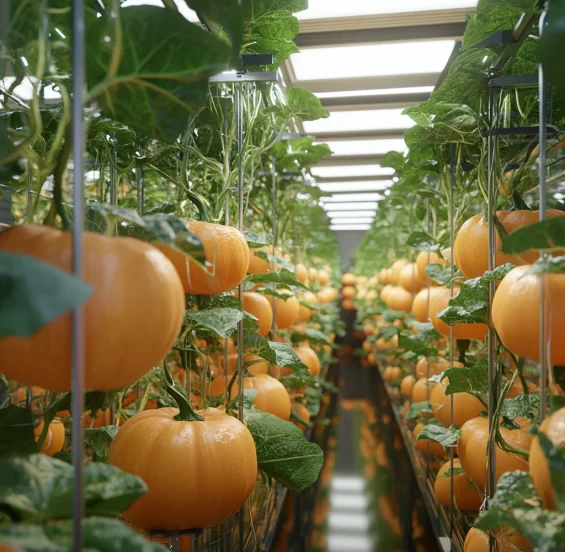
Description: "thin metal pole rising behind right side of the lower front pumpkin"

(235, 85), (244, 550)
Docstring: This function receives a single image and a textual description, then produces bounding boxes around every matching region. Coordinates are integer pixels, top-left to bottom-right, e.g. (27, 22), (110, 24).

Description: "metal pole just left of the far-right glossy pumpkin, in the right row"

(486, 83), (498, 552)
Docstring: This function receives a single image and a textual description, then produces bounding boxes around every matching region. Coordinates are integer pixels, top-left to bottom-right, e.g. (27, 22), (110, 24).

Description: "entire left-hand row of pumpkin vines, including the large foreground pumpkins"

(0, 0), (340, 552)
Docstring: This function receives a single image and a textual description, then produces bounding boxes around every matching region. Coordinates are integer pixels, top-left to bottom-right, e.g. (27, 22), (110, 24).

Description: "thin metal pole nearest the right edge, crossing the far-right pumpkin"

(538, 2), (551, 422)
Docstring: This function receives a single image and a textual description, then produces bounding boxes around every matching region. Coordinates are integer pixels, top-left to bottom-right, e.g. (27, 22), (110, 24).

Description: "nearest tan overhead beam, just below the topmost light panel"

(295, 23), (465, 48)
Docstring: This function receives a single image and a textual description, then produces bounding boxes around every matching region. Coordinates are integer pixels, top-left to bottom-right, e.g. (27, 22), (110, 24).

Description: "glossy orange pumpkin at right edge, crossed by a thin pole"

(492, 266), (565, 366)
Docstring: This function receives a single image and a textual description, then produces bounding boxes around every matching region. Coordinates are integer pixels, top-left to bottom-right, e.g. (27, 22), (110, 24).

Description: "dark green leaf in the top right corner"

(538, 2), (565, 93)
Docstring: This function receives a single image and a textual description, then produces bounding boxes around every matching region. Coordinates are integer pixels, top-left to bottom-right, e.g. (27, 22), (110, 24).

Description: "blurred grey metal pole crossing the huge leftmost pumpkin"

(71, 0), (86, 552)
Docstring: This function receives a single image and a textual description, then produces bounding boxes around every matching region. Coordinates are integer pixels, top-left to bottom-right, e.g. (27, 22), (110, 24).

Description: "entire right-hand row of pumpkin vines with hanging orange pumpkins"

(349, 0), (565, 552)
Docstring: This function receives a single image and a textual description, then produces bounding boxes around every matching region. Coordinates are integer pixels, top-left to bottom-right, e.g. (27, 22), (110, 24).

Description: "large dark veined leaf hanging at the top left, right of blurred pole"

(86, 6), (232, 142)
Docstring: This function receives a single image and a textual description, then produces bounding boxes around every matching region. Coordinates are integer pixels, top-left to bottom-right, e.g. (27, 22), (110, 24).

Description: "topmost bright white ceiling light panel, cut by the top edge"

(296, 0), (477, 19)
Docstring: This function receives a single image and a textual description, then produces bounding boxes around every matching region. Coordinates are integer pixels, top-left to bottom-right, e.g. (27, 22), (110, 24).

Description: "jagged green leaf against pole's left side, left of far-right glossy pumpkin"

(437, 278), (488, 326)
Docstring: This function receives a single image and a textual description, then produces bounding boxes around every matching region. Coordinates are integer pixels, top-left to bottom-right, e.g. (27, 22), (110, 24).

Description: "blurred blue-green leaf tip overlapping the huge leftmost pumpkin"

(0, 251), (92, 338)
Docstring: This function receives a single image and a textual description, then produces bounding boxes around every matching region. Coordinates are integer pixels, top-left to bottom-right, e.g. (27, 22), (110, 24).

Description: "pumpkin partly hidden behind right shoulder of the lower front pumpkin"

(208, 374), (290, 420)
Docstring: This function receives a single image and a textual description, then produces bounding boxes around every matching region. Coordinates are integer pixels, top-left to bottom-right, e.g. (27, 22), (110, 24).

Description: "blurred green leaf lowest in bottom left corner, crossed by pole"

(0, 517), (163, 552)
